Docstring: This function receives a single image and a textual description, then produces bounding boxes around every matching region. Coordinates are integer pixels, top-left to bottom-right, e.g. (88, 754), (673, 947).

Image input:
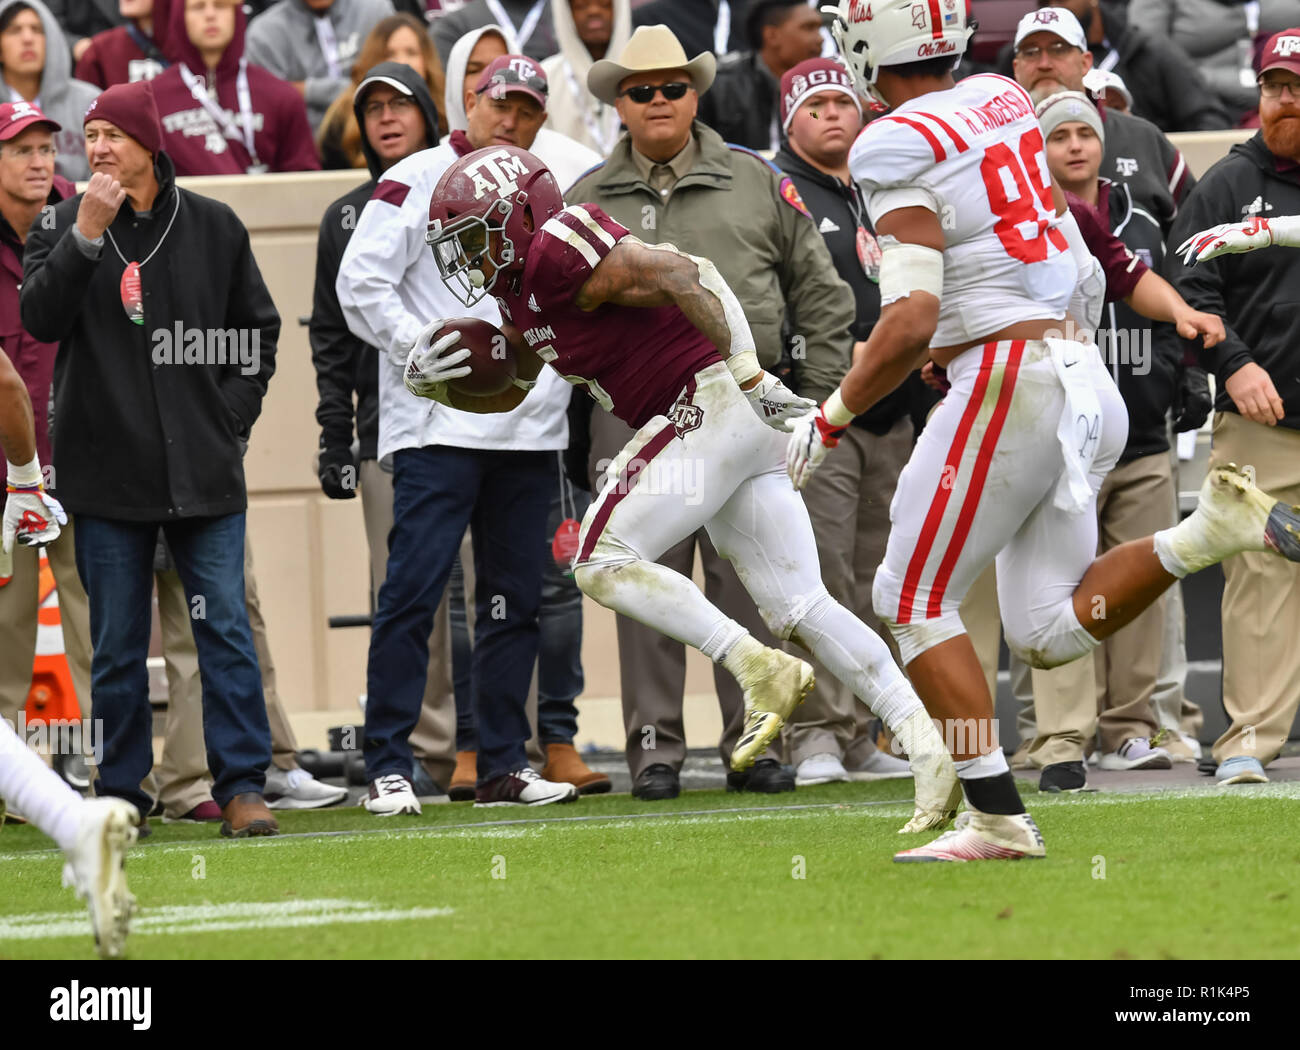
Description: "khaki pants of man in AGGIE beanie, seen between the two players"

(784, 417), (913, 765)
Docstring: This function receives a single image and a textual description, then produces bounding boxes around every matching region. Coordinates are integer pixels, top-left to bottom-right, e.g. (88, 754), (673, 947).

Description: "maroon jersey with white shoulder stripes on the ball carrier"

(497, 204), (722, 429)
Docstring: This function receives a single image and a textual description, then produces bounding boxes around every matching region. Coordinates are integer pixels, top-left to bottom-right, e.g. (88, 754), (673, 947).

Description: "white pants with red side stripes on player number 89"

(873, 340), (1128, 668)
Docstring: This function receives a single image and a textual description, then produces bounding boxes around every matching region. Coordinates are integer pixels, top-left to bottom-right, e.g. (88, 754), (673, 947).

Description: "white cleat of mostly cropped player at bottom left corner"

(64, 798), (140, 959)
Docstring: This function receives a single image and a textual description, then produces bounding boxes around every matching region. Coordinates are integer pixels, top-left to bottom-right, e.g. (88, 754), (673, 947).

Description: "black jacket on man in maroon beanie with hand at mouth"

(20, 152), (280, 521)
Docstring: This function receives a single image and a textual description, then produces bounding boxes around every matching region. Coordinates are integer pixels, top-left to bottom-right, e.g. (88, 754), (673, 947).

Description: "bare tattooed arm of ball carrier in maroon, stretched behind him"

(575, 238), (762, 387)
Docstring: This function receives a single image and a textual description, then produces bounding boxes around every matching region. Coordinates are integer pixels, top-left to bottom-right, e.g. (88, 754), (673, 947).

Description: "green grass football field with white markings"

(0, 781), (1300, 959)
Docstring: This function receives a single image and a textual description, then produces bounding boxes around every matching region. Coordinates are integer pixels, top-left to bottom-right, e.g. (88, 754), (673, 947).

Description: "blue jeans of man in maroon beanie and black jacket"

(77, 512), (270, 815)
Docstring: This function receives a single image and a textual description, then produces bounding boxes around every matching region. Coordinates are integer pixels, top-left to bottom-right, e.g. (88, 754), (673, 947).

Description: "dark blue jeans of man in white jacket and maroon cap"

(364, 446), (550, 784)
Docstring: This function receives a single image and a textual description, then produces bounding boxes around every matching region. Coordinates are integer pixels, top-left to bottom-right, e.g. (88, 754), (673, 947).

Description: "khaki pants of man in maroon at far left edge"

(0, 516), (91, 724)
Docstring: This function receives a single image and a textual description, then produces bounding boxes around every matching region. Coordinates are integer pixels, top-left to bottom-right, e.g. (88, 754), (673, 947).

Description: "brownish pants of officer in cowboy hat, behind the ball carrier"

(589, 409), (777, 780)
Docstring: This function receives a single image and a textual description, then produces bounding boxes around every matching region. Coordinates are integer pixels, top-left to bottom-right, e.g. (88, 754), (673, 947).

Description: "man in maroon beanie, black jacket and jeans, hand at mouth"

(20, 83), (280, 837)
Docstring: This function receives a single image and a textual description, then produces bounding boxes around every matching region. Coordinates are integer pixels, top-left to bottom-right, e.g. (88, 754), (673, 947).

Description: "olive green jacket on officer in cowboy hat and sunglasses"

(564, 121), (854, 402)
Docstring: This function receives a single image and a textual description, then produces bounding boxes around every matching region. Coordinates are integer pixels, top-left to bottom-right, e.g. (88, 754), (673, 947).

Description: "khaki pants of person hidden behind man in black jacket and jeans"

(142, 530), (298, 817)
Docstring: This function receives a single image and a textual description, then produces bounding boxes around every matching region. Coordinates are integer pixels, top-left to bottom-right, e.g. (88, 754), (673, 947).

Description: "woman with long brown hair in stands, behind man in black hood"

(317, 14), (447, 166)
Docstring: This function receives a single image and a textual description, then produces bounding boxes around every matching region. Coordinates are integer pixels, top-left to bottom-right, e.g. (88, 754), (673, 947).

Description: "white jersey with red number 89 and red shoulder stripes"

(849, 74), (1076, 346)
